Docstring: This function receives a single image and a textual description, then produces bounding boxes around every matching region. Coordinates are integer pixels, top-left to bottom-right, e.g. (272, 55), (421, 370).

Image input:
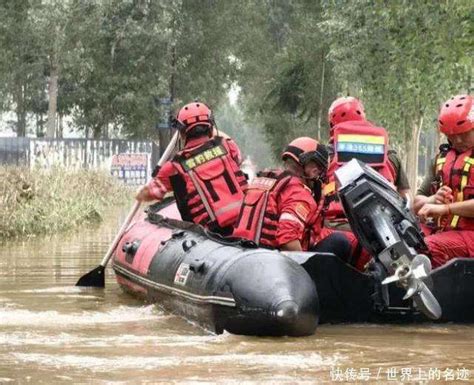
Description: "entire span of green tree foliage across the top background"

(0, 0), (474, 172)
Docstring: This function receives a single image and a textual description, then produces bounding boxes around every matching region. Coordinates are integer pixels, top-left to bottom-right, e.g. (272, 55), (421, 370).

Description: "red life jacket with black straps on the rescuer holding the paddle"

(170, 136), (247, 230)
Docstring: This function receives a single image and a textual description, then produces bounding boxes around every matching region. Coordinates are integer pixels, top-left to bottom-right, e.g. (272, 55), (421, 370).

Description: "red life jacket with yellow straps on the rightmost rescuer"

(432, 144), (474, 230)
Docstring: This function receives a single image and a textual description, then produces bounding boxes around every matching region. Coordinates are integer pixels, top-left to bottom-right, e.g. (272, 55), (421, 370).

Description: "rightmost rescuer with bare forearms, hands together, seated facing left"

(413, 95), (474, 267)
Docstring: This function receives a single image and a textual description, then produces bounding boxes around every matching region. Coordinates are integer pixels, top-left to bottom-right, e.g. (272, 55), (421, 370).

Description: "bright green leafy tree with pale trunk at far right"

(324, 0), (472, 188)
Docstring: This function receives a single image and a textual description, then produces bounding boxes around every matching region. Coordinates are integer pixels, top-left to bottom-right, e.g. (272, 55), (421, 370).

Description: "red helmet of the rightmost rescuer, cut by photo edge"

(438, 95), (474, 135)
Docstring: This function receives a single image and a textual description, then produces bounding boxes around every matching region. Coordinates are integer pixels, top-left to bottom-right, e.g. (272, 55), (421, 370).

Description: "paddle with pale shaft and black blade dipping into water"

(76, 131), (179, 287)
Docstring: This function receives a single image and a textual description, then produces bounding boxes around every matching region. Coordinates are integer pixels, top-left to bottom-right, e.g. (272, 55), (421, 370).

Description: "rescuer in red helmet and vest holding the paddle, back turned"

(136, 102), (247, 235)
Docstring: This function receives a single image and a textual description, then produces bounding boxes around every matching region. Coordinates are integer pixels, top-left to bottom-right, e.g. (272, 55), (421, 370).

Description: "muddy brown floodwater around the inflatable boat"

(0, 206), (474, 384)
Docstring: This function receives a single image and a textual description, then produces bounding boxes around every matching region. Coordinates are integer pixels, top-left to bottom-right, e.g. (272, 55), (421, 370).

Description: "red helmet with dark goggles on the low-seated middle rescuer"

(281, 136), (329, 170)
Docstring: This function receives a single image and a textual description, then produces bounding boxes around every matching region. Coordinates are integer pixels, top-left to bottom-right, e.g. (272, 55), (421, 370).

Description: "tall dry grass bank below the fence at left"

(0, 166), (131, 239)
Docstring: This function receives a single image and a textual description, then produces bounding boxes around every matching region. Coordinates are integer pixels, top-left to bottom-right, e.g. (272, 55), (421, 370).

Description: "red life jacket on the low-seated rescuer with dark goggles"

(233, 170), (319, 249)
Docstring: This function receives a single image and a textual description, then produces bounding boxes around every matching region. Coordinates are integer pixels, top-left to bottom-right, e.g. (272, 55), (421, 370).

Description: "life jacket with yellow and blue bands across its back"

(323, 121), (396, 222)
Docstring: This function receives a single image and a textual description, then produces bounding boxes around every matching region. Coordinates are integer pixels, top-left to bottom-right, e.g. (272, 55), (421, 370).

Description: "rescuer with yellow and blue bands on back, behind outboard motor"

(322, 96), (410, 270)
